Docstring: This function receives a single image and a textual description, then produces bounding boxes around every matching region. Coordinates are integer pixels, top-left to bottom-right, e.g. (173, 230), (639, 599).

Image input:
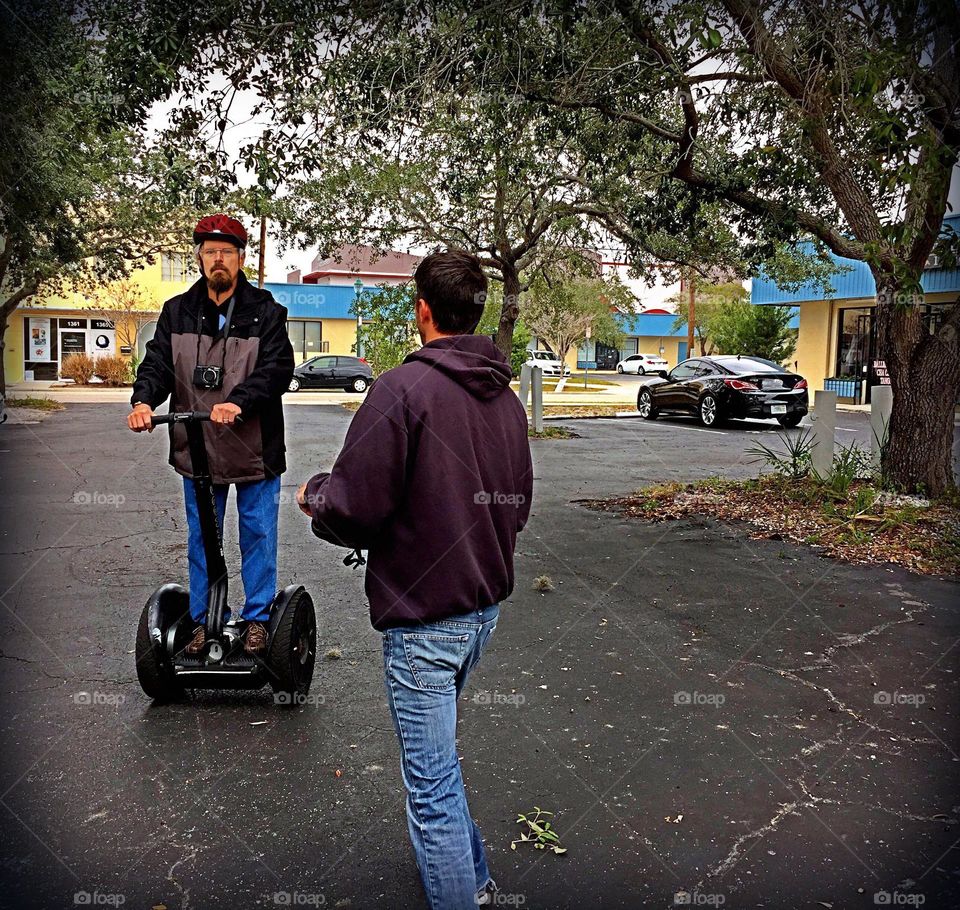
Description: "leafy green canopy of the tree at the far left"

(0, 2), (204, 390)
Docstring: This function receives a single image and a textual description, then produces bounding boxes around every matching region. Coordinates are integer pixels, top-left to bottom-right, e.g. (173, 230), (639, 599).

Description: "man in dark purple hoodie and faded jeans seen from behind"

(298, 252), (533, 910)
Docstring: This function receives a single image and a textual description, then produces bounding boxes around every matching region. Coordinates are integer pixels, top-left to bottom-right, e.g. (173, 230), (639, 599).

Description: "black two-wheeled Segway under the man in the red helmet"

(136, 411), (317, 706)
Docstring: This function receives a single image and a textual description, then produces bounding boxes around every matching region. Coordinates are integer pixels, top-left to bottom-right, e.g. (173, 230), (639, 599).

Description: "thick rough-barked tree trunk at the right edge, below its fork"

(876, 276), (960, 496)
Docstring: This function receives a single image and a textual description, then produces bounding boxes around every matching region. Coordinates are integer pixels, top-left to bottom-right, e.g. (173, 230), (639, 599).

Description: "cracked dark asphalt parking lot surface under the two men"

(0, 404), (960, 910)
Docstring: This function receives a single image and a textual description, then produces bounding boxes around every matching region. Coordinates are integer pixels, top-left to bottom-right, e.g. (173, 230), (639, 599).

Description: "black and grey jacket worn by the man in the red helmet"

(131, 272), (293, 483)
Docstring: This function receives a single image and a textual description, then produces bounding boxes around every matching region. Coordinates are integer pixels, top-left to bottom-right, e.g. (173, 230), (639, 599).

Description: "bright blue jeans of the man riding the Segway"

(183, 477), (280, 623)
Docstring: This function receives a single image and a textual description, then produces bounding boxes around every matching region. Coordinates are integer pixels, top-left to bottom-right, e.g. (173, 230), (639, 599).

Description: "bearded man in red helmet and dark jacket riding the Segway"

(127, 214), (294, 656)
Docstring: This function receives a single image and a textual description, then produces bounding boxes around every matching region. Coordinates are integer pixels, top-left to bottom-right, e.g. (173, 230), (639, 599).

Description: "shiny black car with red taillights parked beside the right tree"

(637, 356), (807, 427)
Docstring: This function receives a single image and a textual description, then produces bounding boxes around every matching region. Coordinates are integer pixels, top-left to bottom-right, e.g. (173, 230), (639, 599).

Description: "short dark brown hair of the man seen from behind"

(413, 250), (487, 335)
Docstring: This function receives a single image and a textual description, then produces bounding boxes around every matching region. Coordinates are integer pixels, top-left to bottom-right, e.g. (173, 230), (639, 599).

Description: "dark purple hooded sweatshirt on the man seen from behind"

(307, 335), (533, 630)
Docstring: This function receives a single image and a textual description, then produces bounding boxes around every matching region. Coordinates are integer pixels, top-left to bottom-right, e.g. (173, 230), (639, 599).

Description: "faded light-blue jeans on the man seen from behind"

(383, 604), (500, 910)
